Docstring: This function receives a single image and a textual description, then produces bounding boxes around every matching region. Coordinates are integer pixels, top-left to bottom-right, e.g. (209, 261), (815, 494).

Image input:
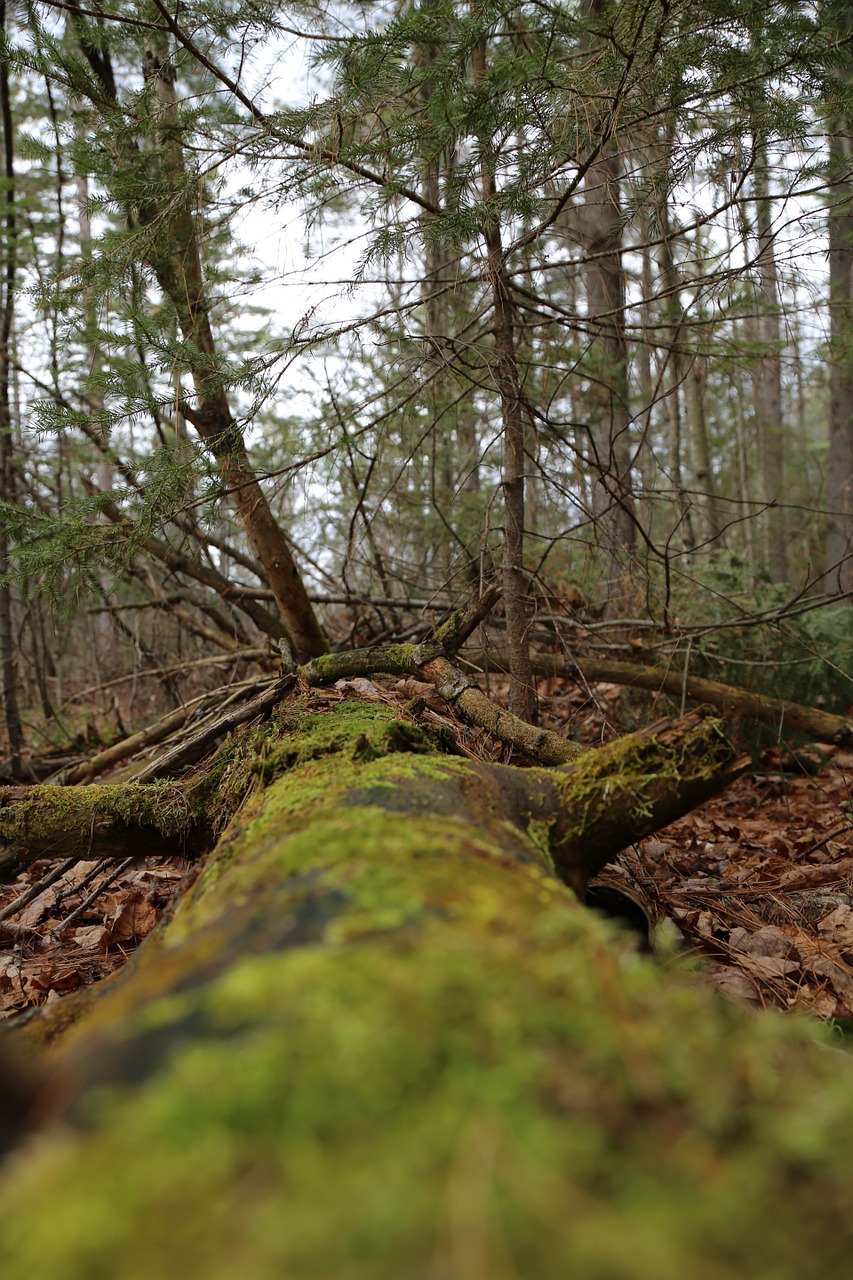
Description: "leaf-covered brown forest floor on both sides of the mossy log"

(0, 680), (853, 1024)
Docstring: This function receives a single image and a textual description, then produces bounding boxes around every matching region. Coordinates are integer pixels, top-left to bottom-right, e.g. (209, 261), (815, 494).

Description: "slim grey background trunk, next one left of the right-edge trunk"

(752, 136), (788, 582)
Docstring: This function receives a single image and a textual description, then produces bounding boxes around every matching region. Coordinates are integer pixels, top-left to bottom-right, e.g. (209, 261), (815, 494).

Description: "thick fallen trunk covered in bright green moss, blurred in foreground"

(0, 703), (853, 1280)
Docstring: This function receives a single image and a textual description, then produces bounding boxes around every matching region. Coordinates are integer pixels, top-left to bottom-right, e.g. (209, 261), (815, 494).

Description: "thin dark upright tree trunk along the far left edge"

(0, 15), (23, 778)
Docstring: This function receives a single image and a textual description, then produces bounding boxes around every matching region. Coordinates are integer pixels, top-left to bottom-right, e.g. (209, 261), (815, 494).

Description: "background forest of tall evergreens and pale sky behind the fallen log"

(0, 0), (853, 757)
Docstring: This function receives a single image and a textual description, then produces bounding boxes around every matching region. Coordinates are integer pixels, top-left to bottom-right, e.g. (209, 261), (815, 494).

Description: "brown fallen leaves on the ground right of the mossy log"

(624, 749), (853, 1018)
